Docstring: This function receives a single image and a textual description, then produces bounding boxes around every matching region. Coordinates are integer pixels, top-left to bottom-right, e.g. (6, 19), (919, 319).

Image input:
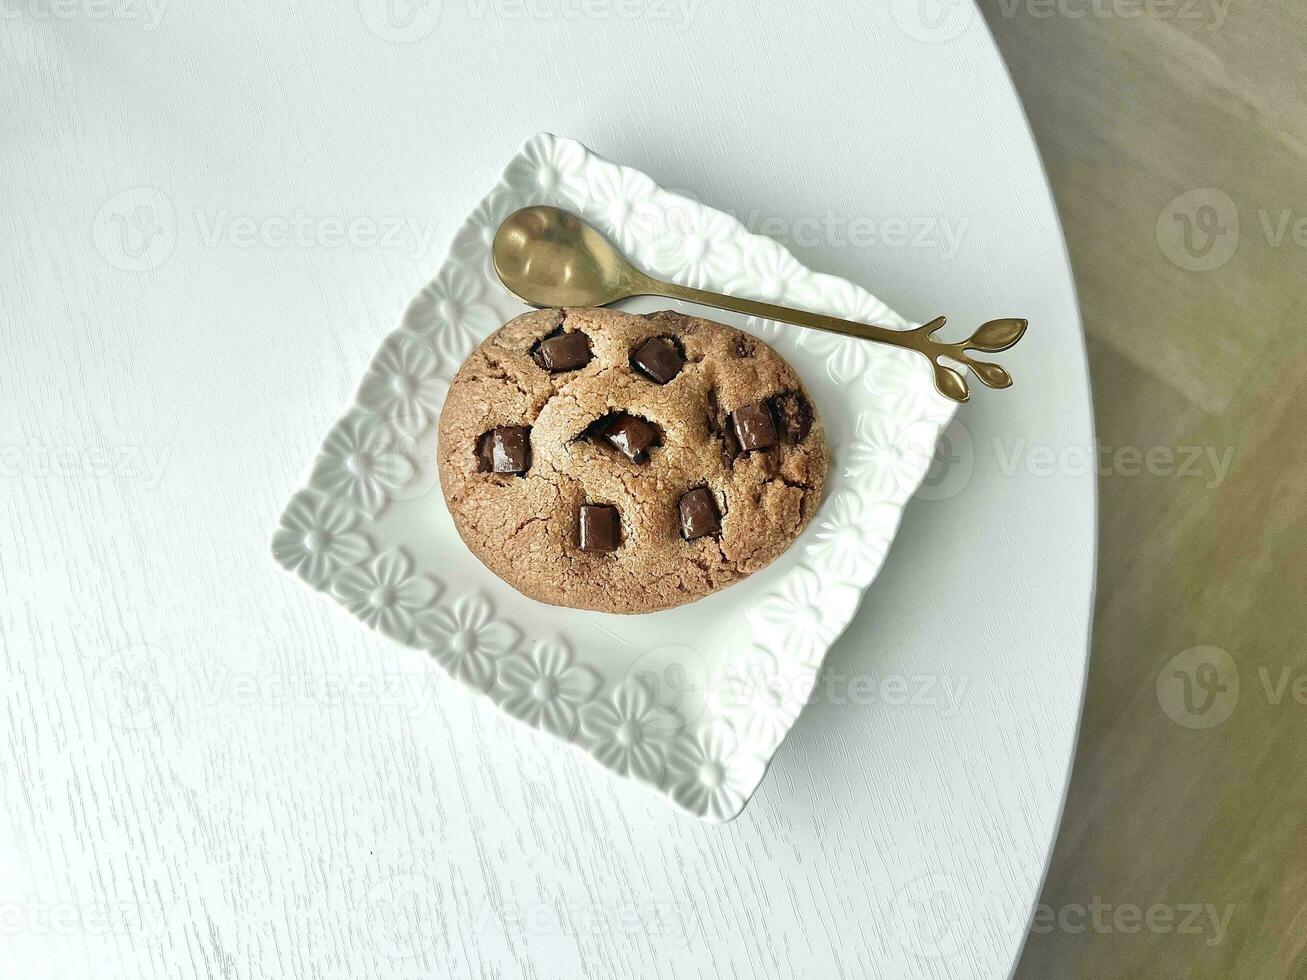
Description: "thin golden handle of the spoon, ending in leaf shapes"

(640, 277), (1027, 401)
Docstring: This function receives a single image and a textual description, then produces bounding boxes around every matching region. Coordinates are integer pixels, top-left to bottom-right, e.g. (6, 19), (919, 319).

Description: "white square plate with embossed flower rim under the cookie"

(272, 133), (955, 821)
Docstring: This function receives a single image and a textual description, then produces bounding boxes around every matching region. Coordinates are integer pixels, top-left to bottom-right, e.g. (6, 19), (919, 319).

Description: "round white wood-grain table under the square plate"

(0, 0), (1094, 980)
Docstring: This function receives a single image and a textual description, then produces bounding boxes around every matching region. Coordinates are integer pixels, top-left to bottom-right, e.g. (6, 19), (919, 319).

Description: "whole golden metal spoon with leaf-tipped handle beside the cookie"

(491, 205), (1026, 401)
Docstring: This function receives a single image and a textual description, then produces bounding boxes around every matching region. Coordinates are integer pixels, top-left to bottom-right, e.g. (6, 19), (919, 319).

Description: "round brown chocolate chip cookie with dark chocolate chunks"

(438, 310), (829, 613)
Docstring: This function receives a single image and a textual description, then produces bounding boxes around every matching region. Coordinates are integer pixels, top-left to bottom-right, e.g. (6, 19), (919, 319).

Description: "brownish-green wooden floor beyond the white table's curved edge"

(983, 0), (1307, 977)
